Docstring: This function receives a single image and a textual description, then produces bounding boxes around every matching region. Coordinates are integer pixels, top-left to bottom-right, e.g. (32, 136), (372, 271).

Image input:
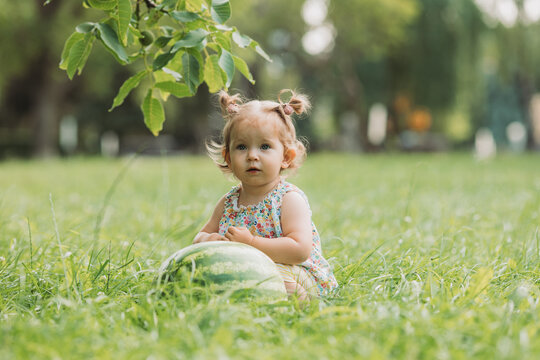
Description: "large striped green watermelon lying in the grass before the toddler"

(157, 241), (287, 299)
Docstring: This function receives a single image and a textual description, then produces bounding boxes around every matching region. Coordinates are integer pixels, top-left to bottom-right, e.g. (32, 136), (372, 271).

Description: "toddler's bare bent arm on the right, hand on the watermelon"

(225, 191), (312, 264)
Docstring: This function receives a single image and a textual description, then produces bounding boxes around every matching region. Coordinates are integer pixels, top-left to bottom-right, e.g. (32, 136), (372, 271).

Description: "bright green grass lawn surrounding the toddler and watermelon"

(0, 154), (540, 359)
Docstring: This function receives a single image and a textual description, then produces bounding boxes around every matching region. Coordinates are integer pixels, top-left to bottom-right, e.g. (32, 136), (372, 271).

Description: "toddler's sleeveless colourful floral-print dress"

(219, 180), (337, 295)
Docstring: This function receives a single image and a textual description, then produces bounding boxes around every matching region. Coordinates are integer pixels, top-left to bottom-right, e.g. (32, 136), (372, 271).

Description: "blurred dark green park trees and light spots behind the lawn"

(0, 0), (540, 159)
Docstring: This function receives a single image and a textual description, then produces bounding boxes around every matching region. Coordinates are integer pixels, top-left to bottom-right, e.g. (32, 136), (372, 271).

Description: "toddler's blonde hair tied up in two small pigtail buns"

(206, 89), (311, 174)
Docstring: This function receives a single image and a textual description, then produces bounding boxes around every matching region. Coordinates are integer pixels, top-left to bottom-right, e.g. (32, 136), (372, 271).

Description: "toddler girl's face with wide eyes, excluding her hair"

(226, 120), (292, 186)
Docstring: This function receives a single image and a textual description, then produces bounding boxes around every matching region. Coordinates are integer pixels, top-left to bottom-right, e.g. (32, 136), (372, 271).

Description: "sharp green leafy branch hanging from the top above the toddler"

(56, 0), (264, 136)
